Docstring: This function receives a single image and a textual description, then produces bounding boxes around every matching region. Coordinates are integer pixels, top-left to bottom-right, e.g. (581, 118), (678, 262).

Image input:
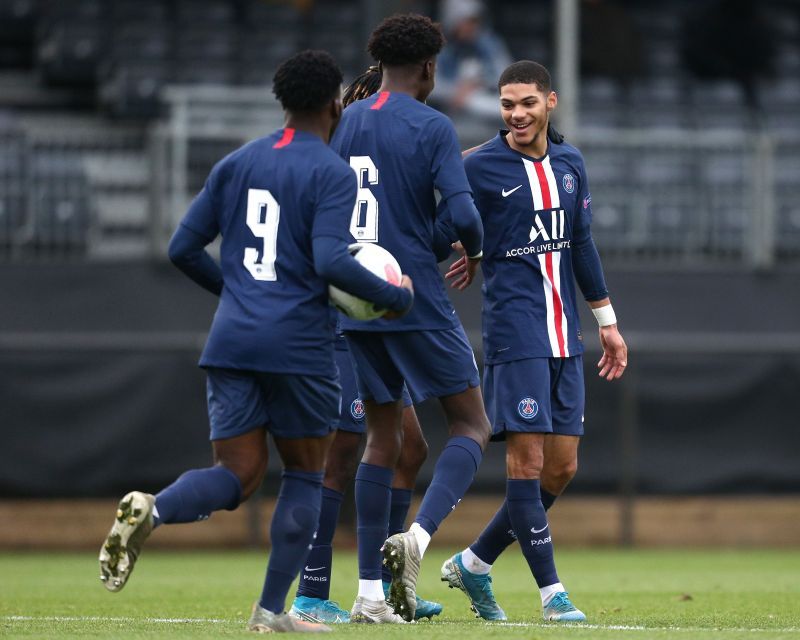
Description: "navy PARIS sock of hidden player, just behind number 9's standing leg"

(297, 487), (344, 600)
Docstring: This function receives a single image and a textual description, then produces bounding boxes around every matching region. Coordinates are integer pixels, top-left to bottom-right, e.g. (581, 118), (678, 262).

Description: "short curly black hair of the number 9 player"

(272, 49), (343, 111)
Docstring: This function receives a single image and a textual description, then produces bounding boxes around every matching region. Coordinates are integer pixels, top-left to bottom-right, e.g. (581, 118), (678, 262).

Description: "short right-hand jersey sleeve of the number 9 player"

(311, 161), (357, 243)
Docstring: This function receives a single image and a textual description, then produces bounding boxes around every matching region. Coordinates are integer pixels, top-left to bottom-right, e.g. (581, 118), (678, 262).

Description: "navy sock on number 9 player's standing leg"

(259, 471), (323, 613)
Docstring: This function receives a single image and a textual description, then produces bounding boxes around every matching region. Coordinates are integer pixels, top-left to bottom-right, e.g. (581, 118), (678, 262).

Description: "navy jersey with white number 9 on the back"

(181, 128), (356, 375)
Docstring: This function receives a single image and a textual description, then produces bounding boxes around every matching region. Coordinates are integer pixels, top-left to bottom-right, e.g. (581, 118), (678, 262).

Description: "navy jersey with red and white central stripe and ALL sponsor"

(464, 132), (607, 364)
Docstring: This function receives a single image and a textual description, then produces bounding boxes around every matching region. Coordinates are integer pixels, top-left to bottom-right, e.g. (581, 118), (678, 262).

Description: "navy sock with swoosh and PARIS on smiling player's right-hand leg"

(506, 480), (558, 588)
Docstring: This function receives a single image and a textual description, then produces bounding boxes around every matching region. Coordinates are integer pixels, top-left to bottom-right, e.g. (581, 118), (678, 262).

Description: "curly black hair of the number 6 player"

(367, 13), (445, 67)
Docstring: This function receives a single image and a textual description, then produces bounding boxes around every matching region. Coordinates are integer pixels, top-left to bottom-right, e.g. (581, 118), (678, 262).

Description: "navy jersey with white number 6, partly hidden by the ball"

(331, 91), (477, 331)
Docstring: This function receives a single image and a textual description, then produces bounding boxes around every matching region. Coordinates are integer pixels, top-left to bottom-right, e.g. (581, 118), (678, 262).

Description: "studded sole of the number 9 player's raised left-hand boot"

(98, 491), (152, 593)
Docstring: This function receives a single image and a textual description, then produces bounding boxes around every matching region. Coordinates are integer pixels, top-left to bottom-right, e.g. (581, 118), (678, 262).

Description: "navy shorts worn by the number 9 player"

(206, 367), (341, 440)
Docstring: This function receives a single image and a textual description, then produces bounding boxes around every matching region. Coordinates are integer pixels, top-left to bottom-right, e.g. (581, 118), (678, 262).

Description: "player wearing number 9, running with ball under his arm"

(99, 51), (413, 632)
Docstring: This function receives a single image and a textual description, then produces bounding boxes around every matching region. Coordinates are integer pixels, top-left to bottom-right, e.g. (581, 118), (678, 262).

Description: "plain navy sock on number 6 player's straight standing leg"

(355, 462), (394, 580)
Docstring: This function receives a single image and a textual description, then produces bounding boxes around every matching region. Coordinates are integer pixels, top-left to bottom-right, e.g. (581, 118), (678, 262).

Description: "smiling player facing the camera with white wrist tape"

(442, 61), (627, 621)
